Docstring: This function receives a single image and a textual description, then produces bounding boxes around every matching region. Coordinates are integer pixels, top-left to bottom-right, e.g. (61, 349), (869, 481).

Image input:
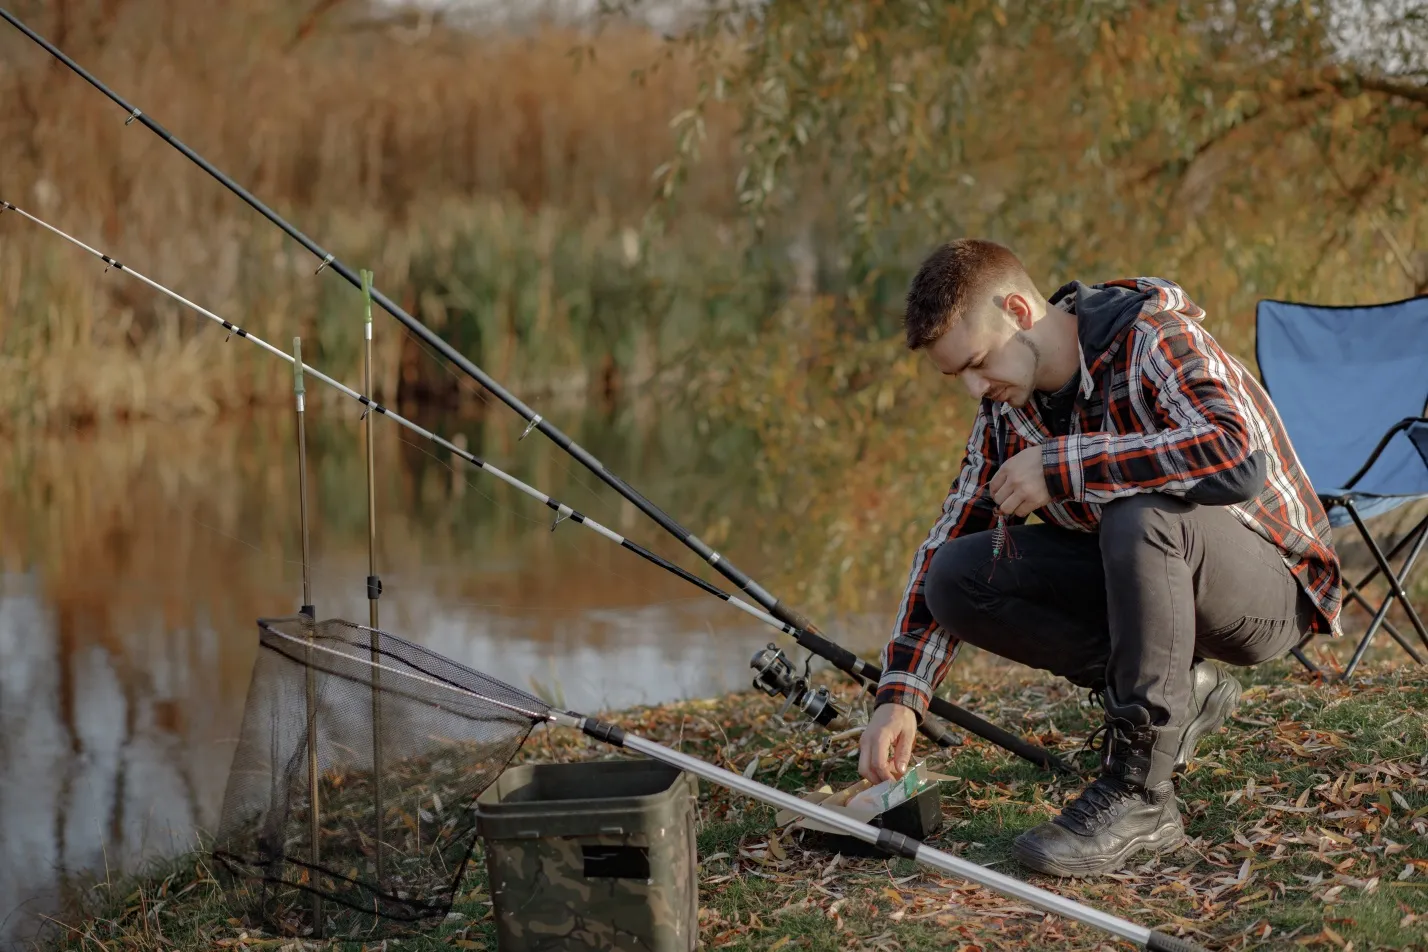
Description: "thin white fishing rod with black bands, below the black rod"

(0, 200), (822, 656)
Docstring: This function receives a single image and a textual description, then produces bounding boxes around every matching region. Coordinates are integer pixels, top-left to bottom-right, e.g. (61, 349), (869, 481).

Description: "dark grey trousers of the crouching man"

(925, 492), (1314, 775)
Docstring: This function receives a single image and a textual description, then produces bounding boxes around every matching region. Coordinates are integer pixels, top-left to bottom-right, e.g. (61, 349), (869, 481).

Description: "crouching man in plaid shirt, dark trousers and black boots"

(860, 240), (1339, 876)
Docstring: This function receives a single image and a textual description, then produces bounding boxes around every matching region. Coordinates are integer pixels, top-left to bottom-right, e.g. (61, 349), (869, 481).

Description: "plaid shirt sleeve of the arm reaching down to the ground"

(874, 402), (997, 719)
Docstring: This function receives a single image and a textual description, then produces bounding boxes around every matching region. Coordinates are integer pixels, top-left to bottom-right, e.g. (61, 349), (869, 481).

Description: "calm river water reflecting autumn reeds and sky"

(0, 401), (877, 948)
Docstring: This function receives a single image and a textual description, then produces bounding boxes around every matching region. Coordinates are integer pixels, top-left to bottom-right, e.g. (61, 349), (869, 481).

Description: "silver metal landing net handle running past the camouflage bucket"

(548, 722), (1204, 952)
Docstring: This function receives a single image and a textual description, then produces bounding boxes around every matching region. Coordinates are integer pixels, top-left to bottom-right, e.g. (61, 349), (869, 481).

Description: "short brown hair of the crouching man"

(902, 238), (1035, 350)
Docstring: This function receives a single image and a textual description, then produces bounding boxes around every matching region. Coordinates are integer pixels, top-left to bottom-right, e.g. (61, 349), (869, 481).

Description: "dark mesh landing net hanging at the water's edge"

(213, 615), (548, 939)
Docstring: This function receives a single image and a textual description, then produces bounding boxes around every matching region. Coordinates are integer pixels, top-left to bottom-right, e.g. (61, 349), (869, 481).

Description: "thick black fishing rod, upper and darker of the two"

(0, 7), (1074, 774)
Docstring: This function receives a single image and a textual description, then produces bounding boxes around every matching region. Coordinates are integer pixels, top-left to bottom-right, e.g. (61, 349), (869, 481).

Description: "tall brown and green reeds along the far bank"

(0, 0), (753, 425)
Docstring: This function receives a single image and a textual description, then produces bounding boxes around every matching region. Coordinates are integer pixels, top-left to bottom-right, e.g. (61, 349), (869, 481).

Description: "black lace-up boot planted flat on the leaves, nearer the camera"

(1012, 697), (1185, 876)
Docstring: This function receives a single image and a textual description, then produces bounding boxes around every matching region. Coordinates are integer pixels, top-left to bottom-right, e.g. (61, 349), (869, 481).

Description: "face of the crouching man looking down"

(927, 295), (1037, 407)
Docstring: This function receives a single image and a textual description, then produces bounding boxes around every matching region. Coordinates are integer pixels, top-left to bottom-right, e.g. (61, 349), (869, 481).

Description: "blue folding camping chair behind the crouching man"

(1255, 295), (1428, 679)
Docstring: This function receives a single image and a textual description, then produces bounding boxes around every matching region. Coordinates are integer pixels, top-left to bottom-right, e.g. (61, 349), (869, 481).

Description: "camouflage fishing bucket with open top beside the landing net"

(476, 759), (700, 952)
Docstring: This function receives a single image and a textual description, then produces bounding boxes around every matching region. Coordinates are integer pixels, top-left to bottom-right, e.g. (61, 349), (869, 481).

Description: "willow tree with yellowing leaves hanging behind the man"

(618, 0), (1428, 608)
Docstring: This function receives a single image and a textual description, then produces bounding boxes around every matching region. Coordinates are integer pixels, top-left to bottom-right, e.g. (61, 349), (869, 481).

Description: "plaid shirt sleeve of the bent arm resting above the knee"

(1041, 321), (1254, 502)
